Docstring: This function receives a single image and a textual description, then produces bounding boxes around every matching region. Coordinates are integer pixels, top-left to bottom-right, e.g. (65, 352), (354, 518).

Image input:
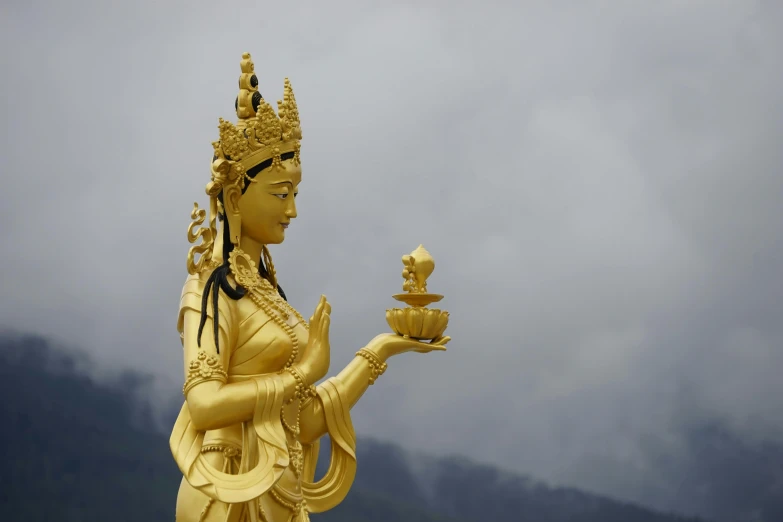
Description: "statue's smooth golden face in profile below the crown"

(239, 160), (302, 245)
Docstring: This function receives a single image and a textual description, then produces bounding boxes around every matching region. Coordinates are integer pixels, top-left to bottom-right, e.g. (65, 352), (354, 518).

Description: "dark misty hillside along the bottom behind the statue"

(0, 338), (783, 522)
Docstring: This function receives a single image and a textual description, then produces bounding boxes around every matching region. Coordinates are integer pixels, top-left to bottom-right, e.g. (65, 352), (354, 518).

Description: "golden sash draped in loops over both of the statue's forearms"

(169, 374), (356, 522)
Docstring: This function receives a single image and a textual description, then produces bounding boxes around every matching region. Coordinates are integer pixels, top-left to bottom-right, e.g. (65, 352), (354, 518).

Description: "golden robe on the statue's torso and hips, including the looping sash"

(170, 270), (356, 522)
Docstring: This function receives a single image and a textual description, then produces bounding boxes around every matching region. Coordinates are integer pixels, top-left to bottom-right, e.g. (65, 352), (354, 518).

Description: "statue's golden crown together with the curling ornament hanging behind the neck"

(188, 53), (302, 274)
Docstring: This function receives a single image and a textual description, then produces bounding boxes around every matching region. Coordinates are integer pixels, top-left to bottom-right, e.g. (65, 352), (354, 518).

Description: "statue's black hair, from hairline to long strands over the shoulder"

(197, 152), (296, 353)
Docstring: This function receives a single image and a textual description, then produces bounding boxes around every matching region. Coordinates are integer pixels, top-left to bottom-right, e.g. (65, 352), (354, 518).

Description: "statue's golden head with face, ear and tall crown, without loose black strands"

(189, 53), (302, 272)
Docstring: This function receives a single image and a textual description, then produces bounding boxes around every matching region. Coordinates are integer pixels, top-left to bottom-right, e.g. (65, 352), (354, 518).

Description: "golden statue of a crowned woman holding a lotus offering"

(170, 53), (449, 522)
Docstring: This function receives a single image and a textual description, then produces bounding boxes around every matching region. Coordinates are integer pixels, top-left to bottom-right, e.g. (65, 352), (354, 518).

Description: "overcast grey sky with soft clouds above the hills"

(0, 0), (783, 503)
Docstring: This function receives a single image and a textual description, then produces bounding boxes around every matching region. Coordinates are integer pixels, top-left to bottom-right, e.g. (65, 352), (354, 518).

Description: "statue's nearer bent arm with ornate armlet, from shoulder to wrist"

(183, 309), (296, 431)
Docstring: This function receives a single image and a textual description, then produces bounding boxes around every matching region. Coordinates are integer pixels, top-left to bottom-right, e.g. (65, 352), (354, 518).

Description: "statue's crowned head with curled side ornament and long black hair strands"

(188, 53), (302, 347)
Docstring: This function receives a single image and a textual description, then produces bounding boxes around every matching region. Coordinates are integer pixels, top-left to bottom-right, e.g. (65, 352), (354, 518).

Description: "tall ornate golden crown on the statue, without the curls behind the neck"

(207, 53), (302, 196)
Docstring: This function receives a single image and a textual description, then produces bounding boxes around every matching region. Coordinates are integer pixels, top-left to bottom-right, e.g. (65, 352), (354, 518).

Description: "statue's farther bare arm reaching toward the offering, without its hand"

(299, 348), (385, 444)
